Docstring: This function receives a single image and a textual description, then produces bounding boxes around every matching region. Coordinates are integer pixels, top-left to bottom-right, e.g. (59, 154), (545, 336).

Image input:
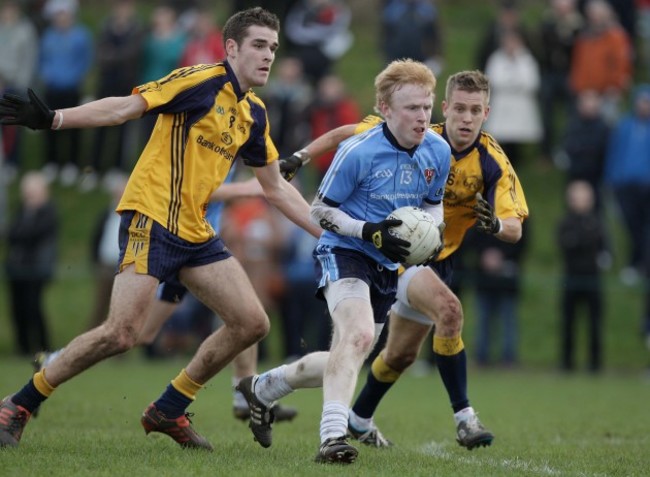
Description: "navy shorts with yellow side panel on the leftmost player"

(118, 210), (232, 286)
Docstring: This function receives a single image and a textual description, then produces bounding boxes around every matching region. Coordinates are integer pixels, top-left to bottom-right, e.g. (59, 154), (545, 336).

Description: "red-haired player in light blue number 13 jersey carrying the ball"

(234, 60), (451, 463)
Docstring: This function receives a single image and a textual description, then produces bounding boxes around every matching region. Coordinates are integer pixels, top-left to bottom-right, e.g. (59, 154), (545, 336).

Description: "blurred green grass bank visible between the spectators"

(0, 0), (649, 371)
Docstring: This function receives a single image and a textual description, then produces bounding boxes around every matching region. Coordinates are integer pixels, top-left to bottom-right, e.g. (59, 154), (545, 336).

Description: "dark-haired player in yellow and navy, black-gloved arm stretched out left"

(0, 7), (321, 450)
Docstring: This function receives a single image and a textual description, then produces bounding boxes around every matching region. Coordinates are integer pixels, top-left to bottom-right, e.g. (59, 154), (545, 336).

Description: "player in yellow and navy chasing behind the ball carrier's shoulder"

(280, 71), (528, 450)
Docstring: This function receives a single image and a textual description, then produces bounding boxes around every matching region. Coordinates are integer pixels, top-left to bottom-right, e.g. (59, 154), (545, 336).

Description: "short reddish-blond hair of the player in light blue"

(375, 58), (436, 112)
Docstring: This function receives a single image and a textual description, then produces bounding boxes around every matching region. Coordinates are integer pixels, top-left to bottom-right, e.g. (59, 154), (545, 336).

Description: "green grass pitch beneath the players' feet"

(0, 351), (650, 477)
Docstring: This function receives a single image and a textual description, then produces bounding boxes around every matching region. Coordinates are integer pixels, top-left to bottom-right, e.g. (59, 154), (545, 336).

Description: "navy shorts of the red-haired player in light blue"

(314, 245), (397, 323)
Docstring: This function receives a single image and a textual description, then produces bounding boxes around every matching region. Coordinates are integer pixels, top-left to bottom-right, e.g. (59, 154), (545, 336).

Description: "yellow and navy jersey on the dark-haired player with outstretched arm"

(117, 62), (278, 243)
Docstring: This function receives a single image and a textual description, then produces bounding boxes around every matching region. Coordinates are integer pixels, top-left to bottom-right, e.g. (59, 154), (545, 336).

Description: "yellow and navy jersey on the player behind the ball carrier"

(355, 115), (528, 260)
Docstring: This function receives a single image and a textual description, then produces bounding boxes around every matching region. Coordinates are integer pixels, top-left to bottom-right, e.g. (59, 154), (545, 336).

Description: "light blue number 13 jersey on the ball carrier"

(318, 123), (451, 270)
